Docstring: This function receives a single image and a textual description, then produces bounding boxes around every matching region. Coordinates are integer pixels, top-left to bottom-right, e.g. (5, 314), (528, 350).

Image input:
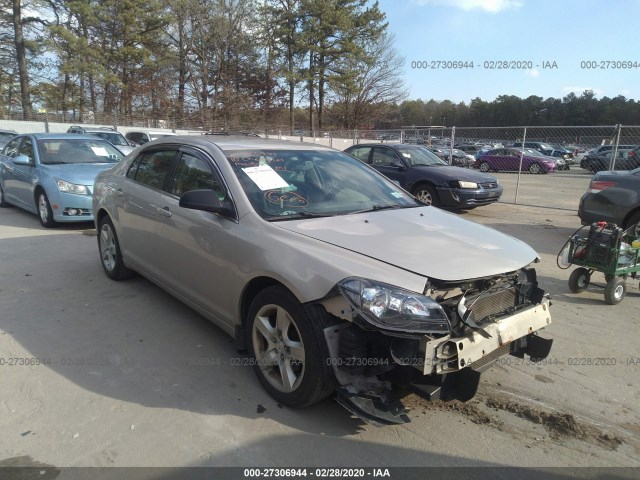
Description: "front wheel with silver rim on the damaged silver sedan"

(247, 286), (337, 407)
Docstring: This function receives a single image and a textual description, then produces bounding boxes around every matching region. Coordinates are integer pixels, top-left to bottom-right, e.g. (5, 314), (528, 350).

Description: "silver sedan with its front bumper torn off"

(93, 136), (551, 424)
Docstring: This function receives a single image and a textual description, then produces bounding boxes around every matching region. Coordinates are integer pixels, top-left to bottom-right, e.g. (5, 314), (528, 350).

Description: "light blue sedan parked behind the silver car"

(0, 133), (124, 228)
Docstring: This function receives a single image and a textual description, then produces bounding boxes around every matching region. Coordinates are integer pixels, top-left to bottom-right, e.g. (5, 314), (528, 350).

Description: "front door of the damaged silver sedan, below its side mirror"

(156, 147), (240, 324)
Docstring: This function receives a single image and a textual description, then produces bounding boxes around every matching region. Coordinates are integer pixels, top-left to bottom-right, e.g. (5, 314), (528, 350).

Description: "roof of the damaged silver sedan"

(153, 135), (336, 151)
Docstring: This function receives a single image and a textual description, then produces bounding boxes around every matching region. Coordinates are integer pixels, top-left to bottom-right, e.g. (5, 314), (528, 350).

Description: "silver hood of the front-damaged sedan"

(273, 207), (537, 281)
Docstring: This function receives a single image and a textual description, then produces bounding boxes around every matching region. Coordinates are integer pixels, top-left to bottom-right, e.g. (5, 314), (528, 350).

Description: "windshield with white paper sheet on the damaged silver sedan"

(225, 150), (421, 220)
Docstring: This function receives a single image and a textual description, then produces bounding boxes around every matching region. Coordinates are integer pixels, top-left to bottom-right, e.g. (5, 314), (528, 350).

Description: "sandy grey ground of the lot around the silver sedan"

(0, 200), (640, 478)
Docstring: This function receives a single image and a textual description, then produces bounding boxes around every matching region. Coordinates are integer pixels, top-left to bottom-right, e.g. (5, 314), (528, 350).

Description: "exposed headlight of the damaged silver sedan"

(338, 277), (451, 333)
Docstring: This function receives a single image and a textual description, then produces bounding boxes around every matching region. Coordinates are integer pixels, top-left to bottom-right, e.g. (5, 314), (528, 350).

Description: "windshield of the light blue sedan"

(38, 138), (124, 165)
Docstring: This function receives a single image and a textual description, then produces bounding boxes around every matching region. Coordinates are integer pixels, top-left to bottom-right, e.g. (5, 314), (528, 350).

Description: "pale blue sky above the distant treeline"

(379, 0), (640, 104)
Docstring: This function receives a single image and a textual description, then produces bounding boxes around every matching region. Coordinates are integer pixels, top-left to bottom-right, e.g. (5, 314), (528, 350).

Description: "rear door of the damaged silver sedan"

(116, 147), (178, 278)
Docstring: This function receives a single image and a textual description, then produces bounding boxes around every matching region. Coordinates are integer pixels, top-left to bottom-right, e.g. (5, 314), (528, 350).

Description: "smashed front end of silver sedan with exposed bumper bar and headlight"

(322, 268), (552, 424)
